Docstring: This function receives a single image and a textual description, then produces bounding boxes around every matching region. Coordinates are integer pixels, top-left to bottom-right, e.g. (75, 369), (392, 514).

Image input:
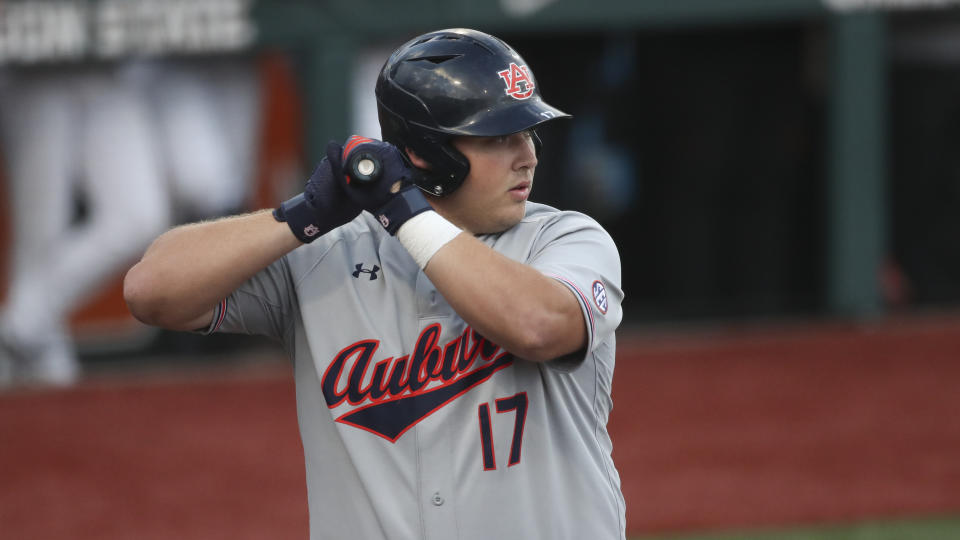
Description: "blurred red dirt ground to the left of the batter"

(0, 358), (307, 540)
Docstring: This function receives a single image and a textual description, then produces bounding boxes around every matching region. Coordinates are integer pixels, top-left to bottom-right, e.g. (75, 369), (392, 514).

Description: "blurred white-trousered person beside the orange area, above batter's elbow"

(135, 57), (260, 223)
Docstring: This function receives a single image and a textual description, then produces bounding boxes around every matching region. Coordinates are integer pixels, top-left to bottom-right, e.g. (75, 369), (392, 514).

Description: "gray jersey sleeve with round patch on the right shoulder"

(527, 212), (623, 369)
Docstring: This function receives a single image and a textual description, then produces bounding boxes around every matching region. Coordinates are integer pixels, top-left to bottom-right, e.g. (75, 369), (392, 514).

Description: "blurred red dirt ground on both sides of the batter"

(0, 317), (960, 539)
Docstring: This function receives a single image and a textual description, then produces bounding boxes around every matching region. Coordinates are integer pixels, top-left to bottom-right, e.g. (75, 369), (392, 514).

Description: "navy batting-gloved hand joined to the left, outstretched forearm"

(273, 154), (363, 244)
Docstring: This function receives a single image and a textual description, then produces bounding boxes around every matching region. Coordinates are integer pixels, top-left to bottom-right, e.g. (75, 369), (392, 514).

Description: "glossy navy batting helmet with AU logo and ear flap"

(376, 28), (570, 196)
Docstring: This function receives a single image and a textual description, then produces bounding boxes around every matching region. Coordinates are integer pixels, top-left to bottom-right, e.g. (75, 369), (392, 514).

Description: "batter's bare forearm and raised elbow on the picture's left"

(124, 211), (301, 330)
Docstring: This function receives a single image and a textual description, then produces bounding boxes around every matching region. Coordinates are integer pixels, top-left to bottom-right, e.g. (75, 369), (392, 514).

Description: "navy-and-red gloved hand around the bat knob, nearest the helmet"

(327, 135), (432, 234)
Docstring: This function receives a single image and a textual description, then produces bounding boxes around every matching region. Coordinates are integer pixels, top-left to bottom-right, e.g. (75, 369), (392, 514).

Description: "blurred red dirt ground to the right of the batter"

(610, 318), (960, 531)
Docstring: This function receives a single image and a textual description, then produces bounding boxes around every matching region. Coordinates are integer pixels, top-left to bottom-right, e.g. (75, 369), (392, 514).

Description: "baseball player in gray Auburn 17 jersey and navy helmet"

(125, 29), (625, 540)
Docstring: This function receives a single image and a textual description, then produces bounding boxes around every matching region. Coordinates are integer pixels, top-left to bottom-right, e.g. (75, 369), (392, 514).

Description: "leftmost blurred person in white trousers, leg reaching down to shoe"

(0, 66), (169, 385)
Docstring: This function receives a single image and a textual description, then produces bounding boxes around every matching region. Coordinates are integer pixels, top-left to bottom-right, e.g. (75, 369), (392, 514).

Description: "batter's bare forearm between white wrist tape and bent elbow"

(425, 234), (587, 361)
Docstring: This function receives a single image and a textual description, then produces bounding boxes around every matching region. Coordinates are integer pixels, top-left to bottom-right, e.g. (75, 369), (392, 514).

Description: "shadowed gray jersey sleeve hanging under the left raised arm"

(204, 257), (296, 341)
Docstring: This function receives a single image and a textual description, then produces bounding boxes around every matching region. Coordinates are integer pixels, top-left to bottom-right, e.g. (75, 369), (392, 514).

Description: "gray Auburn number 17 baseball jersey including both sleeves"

(209, 203), (625, 540)
